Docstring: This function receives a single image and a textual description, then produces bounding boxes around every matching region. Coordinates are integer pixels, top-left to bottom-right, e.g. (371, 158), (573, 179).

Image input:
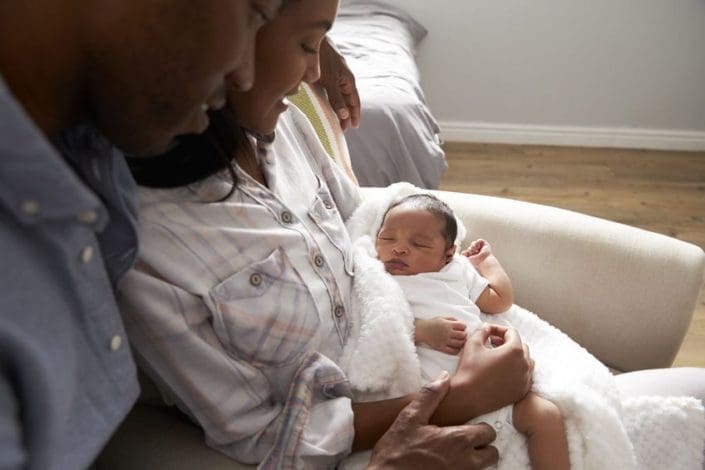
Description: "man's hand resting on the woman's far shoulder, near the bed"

(318, 36), (360, 130)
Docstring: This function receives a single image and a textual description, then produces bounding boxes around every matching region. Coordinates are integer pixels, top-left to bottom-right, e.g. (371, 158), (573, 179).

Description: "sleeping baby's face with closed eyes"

(375, 204), (454, 276)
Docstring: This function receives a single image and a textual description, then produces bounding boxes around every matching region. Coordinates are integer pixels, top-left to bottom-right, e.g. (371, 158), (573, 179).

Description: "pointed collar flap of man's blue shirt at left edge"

(0, 76), (105, 224)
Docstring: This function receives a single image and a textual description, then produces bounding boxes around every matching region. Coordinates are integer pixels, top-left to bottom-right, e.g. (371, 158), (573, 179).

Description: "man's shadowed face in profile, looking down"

(86, 0), (281, 156)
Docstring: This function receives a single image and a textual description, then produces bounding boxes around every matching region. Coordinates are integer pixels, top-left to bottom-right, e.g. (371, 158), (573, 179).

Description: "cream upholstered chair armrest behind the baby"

(364, 189), (705, 371)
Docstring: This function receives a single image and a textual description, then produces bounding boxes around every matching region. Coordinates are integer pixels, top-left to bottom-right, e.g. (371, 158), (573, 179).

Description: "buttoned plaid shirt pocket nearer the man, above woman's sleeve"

(210, 248), (320, 367)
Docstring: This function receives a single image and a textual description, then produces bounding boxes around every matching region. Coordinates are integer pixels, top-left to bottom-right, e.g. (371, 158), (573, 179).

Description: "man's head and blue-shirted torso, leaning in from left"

(0, 0), (280, 469)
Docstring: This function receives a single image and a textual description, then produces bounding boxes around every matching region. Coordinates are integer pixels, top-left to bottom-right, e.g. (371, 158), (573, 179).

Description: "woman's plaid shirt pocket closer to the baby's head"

(308, 179), (353, 276)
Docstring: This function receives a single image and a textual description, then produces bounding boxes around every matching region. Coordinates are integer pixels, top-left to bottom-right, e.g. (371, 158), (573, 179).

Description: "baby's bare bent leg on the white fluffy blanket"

(513, 392), (570, 470)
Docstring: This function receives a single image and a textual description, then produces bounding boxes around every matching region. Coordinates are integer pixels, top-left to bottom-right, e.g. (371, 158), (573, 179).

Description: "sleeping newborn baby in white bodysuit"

(375, 194), (570, 469)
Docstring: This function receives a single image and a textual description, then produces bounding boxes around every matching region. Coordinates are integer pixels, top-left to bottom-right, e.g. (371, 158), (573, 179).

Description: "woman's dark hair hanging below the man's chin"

(127, 106), (254, 199)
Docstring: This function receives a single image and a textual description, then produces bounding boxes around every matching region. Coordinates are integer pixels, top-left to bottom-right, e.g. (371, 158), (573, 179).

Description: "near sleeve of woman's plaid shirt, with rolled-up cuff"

(119, 264), (353, 466)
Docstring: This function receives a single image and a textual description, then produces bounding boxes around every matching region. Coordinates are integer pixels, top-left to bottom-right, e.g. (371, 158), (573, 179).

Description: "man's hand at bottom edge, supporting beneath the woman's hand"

(367, 374), (499, 470)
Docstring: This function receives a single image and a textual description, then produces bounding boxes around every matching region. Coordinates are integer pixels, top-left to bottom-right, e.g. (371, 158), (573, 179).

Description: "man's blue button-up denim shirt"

(0, 77), (138, 470)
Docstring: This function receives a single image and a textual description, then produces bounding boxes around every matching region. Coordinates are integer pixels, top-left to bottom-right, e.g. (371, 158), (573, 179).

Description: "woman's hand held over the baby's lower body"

(433, 325), (534, 425)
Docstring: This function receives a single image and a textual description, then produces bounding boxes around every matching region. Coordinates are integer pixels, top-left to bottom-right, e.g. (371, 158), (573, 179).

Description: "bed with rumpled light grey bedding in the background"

(330, 0), (447, 189)
